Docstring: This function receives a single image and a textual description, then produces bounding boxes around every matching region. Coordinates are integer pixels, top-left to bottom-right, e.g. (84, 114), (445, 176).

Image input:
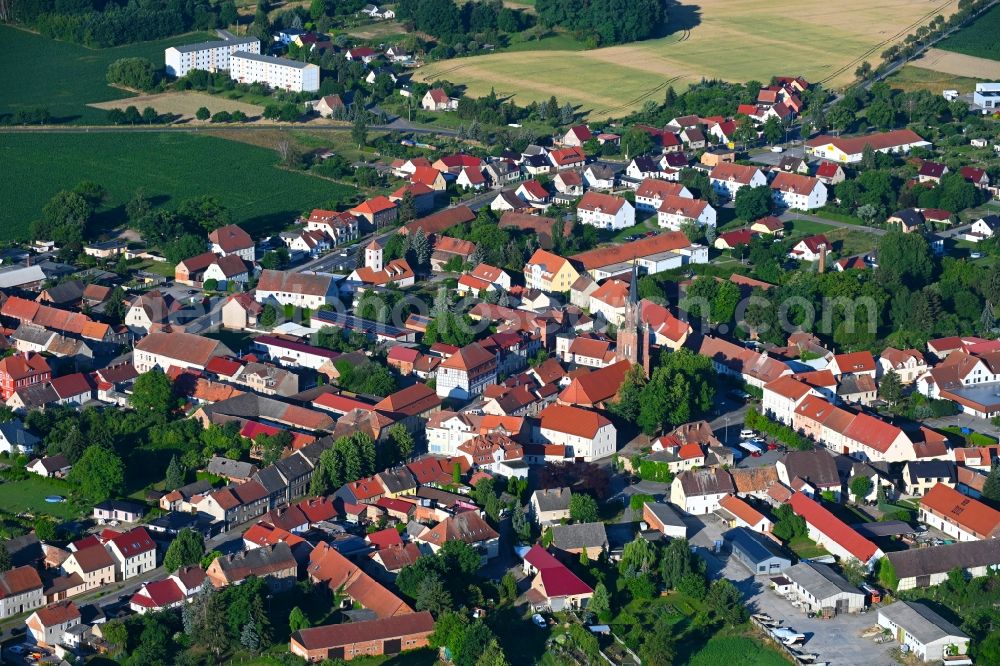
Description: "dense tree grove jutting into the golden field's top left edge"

(535, 0), (667, 46)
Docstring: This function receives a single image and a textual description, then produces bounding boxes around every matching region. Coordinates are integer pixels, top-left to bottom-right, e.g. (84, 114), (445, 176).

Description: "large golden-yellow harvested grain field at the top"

(416, 0), (958, 118)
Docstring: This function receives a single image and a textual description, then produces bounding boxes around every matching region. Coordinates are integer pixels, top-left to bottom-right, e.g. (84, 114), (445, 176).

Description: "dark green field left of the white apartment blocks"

(0, 25), (216, 124)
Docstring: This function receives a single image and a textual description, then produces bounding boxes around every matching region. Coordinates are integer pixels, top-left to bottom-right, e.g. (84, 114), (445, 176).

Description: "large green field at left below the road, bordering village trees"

(0, 132), (355, 239)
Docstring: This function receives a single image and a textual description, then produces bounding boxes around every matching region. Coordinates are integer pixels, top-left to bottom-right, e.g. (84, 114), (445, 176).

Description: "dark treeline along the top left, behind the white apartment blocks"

(14, 0), (236, 48)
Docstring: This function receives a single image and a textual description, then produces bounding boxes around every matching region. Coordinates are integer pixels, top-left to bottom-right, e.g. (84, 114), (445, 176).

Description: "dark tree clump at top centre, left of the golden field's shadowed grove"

(396, 0), (534, 43)
